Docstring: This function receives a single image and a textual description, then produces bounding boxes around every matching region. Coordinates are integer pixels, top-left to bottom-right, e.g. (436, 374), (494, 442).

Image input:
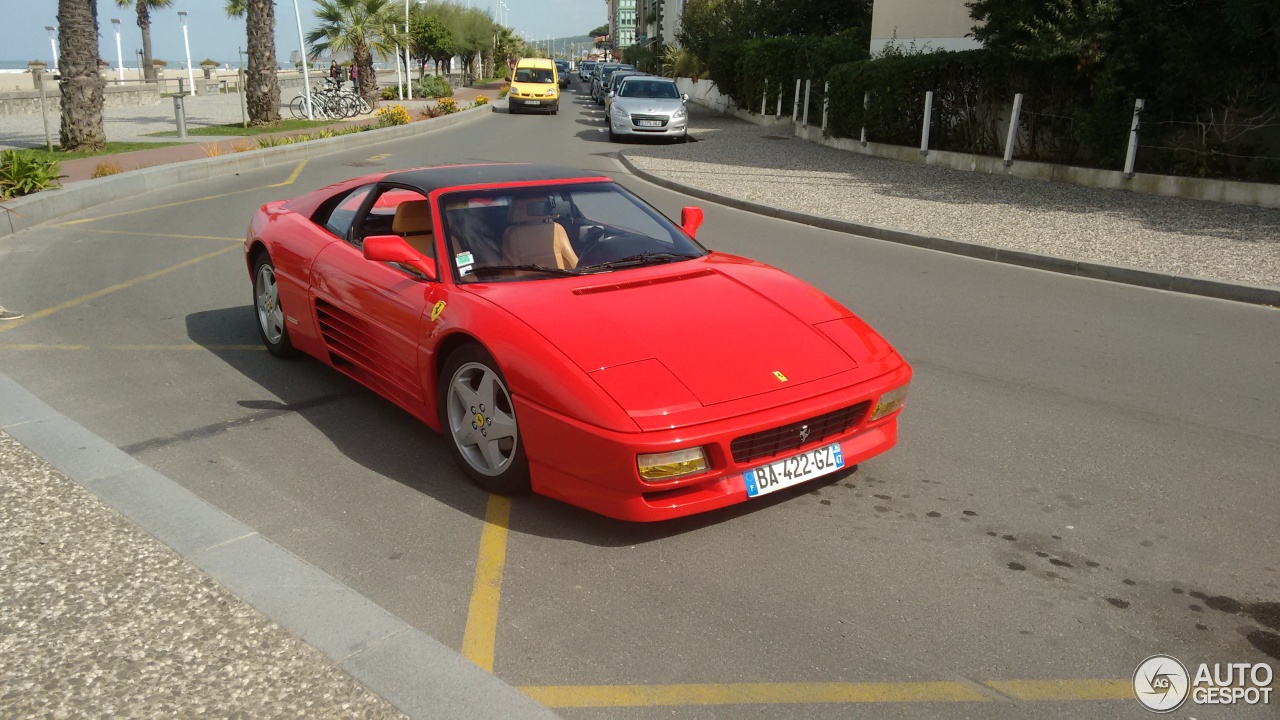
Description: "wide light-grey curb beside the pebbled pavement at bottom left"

(0, 374), (556, 720)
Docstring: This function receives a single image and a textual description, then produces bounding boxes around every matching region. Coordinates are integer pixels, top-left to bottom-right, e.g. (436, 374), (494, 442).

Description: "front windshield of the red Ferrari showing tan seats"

(440, 182), (707, 283)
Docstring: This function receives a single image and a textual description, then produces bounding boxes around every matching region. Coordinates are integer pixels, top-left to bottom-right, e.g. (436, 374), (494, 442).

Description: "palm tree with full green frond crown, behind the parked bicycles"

(307, 0), (404, 105)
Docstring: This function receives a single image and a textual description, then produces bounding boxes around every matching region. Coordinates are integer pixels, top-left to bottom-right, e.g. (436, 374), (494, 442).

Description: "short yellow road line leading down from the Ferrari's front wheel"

(462, 495), (511, 673)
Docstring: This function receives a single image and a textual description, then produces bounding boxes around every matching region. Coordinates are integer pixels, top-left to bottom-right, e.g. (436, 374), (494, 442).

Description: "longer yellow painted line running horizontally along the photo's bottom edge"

(518, 682), (991, 707)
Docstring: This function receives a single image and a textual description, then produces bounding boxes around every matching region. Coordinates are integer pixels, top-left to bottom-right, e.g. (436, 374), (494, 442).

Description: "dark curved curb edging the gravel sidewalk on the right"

(618, 151), (1280, 307)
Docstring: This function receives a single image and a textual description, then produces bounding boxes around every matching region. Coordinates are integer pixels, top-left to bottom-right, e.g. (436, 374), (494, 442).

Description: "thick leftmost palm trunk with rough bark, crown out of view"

(58, 0), (106, 151)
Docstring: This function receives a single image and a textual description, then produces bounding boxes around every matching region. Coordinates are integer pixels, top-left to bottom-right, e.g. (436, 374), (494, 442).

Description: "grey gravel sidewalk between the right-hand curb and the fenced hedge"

(627, 108), (1280, 287)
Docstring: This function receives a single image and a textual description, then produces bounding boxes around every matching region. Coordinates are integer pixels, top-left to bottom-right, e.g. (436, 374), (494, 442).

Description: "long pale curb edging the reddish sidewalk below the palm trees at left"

(0, 104), (493, 237)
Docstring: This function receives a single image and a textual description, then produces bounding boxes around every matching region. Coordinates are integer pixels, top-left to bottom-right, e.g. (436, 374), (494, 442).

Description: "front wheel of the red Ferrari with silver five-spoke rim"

(438, 345), (529, 495)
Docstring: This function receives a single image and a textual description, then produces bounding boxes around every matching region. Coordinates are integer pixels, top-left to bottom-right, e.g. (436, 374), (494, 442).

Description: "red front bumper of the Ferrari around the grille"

(515, 364), (911, 521)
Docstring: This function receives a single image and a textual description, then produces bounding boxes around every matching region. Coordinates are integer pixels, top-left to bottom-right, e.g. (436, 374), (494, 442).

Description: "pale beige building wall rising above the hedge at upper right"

(870, 0), (982, 55)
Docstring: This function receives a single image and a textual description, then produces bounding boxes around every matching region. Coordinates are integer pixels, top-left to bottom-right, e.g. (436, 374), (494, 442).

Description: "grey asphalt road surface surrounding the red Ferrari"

(0, 81), (1280, 719)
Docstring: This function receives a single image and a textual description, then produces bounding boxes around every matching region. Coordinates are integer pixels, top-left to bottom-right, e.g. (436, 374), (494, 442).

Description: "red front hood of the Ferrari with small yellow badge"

(467, 259), (858, 416)
